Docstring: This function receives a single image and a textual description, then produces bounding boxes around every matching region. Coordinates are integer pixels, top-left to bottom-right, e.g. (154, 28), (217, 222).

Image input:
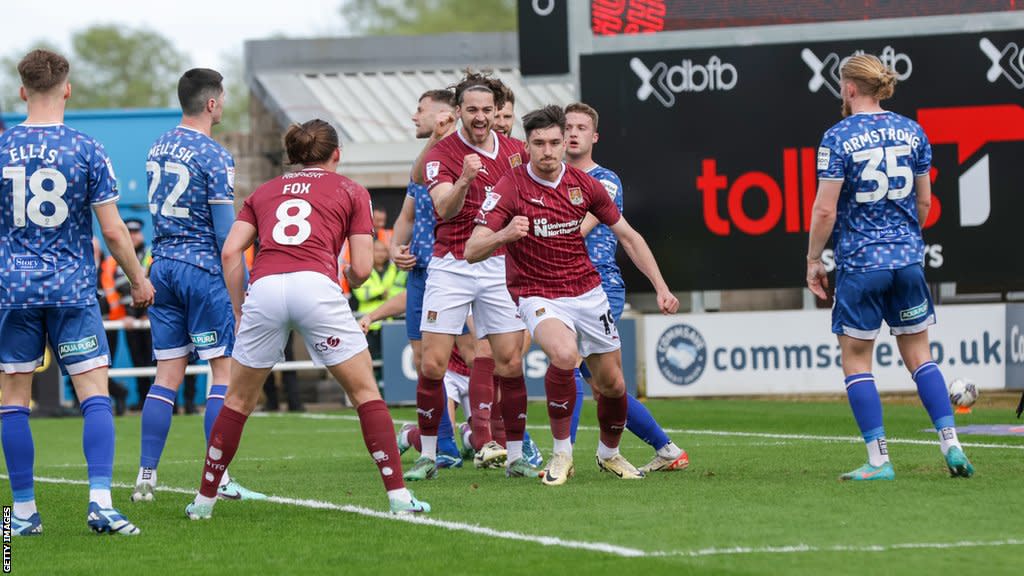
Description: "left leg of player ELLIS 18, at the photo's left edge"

(0, 310), (46, 536)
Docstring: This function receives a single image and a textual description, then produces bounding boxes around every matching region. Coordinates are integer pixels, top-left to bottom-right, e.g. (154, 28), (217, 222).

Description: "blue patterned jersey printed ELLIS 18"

(0, 124), (118, 308)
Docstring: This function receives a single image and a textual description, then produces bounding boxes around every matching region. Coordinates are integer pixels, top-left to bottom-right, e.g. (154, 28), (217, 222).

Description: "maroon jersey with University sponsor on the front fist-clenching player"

(475, 159), (622, 301)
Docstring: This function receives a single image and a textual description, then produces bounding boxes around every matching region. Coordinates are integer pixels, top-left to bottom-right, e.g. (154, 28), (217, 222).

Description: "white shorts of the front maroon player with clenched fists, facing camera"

(519, 286), (621, 358)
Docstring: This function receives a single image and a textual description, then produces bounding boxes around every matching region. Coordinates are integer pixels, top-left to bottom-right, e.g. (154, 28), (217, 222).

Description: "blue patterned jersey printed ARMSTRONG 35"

(817, 112), (932, 272)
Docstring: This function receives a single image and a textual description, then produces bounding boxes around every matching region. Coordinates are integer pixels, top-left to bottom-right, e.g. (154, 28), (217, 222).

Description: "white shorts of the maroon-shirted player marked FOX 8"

(231, 272), (367, 368)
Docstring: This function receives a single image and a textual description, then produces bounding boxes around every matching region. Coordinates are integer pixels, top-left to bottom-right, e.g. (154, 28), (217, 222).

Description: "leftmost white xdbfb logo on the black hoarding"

(630, 55), (739, 108)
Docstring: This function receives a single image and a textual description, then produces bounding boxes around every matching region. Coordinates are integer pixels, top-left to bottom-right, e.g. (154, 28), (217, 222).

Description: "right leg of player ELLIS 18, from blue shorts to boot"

(46, 304), (139, 536)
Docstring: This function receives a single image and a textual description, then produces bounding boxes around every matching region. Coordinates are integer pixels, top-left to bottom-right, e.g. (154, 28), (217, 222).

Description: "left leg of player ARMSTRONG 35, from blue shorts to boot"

(833, 271), (895, 481)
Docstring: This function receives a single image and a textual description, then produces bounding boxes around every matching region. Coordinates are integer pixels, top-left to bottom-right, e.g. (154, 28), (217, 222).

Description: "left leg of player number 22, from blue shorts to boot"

(131, 260), (195, 496)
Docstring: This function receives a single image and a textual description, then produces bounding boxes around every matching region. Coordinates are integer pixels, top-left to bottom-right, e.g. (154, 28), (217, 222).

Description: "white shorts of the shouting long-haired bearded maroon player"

(420, 254), (525, 338)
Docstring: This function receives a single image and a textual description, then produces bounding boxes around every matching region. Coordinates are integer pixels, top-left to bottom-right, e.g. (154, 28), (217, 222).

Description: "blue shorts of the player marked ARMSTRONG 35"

(833, 265), (935, 340)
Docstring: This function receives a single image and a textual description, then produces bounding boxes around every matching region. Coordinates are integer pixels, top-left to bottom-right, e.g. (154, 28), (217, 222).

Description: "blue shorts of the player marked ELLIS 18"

(0, 304), (111, 376)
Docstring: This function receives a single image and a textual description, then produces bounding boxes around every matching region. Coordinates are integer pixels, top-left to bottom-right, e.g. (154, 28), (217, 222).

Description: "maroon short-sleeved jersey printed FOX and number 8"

(239, 168), (374, 282)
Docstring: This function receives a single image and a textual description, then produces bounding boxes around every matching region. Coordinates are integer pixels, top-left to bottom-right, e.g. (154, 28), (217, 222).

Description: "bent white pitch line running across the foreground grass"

(0, 475), (1024, 558)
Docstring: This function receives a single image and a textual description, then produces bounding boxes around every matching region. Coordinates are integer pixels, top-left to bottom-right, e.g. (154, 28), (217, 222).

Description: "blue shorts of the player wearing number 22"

(148, 259), (234, 360)
